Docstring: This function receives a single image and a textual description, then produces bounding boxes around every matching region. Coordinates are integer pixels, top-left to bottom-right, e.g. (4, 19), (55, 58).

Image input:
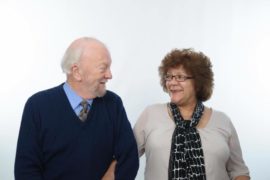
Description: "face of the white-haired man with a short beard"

(78, 46), (112, 98)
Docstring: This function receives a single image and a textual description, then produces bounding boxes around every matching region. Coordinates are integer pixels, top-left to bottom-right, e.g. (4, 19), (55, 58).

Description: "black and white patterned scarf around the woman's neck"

(168, 102), (206, 180)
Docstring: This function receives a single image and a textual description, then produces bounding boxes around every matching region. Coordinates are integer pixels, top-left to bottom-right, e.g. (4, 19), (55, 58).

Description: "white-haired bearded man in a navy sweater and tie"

(15, 37), (139, 180)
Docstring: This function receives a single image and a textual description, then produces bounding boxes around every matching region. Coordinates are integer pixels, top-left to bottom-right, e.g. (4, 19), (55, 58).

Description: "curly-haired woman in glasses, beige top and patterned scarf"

(134, 49), (249, 180)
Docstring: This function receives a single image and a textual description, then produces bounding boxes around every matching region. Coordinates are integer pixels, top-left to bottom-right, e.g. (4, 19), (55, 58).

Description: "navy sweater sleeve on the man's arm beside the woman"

(115, 98), (139, 180)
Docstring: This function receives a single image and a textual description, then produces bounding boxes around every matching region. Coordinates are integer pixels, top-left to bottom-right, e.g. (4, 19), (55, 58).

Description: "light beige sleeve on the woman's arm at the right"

(227, 122), (249, 179)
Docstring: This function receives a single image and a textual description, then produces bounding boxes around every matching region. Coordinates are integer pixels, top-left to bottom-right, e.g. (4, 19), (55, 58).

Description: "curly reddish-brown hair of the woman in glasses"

(158, 49), (214, 102)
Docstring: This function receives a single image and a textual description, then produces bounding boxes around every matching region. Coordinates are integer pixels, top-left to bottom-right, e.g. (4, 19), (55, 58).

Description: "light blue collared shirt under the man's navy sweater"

(63, 82), (93, 116)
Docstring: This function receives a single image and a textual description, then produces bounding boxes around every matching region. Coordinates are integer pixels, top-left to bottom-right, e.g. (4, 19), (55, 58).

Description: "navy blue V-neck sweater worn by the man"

(15, 85), (139, 180)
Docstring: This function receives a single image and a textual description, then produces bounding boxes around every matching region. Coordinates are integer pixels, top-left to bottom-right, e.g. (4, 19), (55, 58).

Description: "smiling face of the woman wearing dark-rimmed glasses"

(166, 66), (197, 106)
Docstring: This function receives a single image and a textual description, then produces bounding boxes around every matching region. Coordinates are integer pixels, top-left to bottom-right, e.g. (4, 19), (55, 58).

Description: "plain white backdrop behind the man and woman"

(0, 0), (270, 180)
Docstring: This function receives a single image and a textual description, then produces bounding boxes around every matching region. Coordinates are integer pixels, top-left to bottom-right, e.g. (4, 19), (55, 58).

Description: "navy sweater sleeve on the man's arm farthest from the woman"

(14, 99), (42, 180)
